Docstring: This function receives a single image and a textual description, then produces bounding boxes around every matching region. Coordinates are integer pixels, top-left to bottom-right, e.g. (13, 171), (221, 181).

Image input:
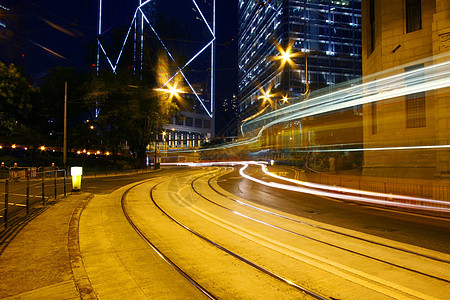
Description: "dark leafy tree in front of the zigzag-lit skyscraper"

(83, 71), (178, 167)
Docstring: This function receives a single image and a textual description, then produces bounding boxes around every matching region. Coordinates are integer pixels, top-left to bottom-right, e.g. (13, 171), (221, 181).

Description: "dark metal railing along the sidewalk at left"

(0, 170), (70, 228)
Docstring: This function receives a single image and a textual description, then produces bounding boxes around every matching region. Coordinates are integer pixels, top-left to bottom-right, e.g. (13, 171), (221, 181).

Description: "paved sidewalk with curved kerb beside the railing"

(0, 193), (96, 299)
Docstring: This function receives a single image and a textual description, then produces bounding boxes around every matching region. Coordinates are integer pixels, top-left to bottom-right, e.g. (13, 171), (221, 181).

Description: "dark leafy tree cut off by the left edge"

(0, 62), (35, 137)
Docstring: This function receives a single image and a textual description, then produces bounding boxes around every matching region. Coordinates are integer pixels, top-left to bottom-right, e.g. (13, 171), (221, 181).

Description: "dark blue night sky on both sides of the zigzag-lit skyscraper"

(0, 0), (237, 127)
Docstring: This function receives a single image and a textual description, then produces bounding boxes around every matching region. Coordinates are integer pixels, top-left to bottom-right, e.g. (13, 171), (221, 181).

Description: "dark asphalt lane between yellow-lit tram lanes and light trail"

(219, 167), (450, 254)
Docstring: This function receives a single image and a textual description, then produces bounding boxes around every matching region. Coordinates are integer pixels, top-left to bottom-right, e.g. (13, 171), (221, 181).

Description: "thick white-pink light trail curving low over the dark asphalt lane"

(239, 163), (450, 212)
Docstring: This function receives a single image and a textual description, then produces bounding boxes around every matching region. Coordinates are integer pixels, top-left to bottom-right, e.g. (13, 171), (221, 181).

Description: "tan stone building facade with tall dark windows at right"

(362, 0), (450, 180)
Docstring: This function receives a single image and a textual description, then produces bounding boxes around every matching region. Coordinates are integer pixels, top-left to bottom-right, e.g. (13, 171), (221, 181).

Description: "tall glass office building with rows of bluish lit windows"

(238, 0), (362, 120)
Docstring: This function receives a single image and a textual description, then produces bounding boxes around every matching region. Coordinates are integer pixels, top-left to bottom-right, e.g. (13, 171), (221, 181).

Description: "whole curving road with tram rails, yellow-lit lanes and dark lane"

(80, 166), (450, 299)
